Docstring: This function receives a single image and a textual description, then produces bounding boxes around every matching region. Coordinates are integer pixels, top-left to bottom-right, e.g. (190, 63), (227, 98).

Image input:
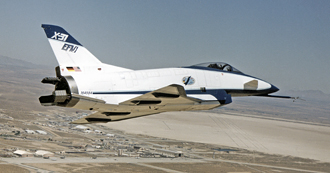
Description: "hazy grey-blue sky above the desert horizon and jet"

(0, 0), (330, 93)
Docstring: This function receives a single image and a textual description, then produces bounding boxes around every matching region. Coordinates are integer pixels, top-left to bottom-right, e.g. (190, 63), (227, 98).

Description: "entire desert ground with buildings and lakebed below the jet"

(0, 56), (330, 172)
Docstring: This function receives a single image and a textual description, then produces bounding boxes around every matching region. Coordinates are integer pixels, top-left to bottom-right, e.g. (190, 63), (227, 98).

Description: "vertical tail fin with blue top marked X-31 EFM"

(41, 24), (129, 73)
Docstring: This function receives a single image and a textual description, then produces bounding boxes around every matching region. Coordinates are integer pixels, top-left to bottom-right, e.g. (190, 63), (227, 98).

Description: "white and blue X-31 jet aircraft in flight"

(39, 24), (290, 124)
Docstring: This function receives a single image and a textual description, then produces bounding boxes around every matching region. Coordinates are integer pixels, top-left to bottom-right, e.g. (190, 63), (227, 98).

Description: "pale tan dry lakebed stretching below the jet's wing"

(105, 112), (330, 162)
